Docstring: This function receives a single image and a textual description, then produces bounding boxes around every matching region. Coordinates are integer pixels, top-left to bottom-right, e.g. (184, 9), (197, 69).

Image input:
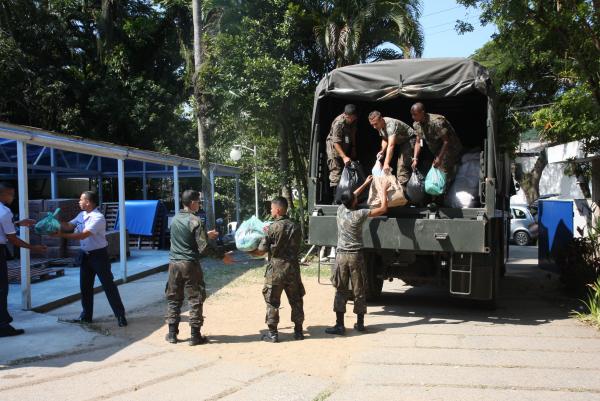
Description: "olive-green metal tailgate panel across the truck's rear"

(308, 216), (489, 253)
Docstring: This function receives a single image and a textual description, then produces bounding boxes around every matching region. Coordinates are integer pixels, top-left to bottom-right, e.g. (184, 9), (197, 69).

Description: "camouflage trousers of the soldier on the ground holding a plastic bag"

(262, 261), (306, 327)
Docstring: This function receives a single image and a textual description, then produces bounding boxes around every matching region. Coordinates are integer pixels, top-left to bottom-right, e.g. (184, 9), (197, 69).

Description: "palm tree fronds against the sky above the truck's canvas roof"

(306, 0), (423, 67)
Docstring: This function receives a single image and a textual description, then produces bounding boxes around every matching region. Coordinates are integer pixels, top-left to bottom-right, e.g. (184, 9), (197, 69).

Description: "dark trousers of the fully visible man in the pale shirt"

(79, 248), (125, 320)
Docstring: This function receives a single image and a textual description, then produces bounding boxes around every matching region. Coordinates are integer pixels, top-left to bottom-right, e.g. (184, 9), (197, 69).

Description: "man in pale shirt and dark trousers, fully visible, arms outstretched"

(55, 191), (127, 327)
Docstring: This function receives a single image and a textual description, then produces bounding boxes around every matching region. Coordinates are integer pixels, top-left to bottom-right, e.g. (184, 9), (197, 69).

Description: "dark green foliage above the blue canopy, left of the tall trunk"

(0, 0), (194, 153)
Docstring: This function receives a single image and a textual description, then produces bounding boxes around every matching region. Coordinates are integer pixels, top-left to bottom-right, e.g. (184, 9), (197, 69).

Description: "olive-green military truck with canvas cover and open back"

(308, 58), (512, 305)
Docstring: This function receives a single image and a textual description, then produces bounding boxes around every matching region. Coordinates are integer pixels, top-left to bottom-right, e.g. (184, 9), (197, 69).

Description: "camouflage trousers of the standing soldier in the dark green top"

(166, 260), (206, 327)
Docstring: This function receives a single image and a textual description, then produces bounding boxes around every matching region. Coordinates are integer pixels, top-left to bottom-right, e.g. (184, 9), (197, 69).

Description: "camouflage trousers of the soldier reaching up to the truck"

(331, 249), (367, 315)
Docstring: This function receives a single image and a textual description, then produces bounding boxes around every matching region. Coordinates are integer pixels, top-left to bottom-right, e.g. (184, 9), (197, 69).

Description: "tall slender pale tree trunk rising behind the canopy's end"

(192, 0), (215, 229)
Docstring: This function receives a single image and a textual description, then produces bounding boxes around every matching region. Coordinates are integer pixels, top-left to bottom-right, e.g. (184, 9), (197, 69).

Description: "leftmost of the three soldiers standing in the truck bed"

(325, 104), (357, 194)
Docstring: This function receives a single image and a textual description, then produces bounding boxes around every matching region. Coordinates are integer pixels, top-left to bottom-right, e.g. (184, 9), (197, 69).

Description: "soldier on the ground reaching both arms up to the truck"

(325, 176), (390, 335)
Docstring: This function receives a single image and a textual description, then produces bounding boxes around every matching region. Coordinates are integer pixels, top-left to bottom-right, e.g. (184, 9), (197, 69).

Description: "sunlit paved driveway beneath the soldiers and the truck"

(0, 244), (600, 401)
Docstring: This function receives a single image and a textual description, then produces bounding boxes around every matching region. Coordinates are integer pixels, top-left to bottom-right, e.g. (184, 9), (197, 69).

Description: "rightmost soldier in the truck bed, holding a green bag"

(410, 103), (462, 183)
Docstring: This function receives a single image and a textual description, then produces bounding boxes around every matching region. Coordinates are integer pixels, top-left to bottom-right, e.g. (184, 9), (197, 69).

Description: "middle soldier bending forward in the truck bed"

(369, 110), (416, 186)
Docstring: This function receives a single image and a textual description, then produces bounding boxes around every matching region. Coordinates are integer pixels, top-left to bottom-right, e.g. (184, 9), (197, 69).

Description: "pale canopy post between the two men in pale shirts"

(17, 141), (31, 310)
